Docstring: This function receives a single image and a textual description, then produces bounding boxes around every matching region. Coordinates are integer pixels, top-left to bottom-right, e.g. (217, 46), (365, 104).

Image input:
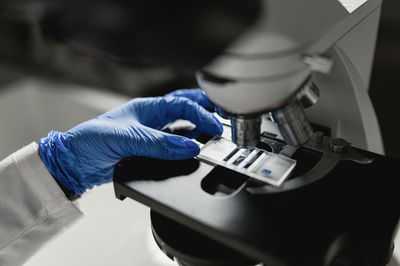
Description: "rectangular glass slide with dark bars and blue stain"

(197, 136), (296, 187)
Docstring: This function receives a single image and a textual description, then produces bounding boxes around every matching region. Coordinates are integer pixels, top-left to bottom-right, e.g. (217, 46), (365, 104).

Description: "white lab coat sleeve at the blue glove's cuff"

(0, 143), (82, 266)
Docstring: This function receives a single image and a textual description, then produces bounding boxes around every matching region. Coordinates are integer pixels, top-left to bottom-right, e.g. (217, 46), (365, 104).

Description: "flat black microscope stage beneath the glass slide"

(114, 142), (400, 265)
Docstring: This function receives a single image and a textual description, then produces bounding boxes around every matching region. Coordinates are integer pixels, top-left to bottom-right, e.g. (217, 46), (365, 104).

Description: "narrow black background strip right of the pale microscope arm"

(370, 0), (400, 159)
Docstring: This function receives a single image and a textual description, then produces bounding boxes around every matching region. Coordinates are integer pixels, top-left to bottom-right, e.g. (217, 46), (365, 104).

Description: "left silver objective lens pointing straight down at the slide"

(231, 115), (261, 148)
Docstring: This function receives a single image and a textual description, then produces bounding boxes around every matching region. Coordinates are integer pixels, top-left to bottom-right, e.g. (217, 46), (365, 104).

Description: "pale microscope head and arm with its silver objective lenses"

(197, 0), (383, 153)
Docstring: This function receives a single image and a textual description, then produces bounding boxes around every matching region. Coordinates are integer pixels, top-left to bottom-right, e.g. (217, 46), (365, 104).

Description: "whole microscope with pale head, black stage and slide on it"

(114, 0), (399, 266)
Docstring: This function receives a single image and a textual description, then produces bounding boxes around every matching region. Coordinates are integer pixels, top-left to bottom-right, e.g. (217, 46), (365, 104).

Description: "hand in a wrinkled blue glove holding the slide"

(39, 90), (223, 195)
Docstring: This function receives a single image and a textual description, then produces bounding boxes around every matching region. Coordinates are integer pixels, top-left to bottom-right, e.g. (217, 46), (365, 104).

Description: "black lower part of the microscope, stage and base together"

(114, 133), (400, 266)
